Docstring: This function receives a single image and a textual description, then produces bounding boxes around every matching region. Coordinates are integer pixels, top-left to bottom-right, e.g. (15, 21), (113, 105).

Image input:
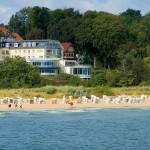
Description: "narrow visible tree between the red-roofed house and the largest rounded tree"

(75, 11), (98, 68)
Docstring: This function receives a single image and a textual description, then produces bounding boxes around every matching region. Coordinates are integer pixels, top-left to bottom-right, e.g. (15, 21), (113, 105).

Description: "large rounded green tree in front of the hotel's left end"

(0, 56), (42, 88)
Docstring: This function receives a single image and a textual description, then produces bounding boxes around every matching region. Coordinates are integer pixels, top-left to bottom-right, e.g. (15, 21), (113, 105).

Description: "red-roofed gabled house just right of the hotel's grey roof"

(61, 43), (77, 60)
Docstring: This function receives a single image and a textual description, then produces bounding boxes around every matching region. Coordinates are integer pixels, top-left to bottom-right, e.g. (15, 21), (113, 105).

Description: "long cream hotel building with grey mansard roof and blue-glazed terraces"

(0, 40), (92, 79)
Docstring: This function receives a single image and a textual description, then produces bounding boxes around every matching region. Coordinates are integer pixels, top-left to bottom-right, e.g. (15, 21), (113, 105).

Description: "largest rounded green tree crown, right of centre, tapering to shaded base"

(91, 13), (128, 69)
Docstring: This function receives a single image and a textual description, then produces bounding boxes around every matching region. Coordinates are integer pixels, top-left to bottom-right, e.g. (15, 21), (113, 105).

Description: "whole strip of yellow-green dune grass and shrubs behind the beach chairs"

(0, 86), (150, 99)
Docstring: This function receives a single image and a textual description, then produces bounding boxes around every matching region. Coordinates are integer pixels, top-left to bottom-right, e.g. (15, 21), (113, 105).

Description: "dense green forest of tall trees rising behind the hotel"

(1, 6), (150, 87)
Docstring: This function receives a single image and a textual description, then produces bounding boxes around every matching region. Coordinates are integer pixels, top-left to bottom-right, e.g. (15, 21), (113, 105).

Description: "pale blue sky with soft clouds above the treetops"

(0, 0), (150, 25)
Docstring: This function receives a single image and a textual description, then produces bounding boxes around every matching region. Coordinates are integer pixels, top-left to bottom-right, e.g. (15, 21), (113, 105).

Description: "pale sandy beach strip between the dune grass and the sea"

(0, 100), (150, 110)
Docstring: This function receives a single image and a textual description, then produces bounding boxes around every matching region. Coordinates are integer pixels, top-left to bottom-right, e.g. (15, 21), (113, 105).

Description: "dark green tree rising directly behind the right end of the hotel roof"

(48, 8), (81, 43)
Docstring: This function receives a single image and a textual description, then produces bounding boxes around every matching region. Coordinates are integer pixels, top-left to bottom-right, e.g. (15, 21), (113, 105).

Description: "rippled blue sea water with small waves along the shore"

(0, 108), (150, 150)
